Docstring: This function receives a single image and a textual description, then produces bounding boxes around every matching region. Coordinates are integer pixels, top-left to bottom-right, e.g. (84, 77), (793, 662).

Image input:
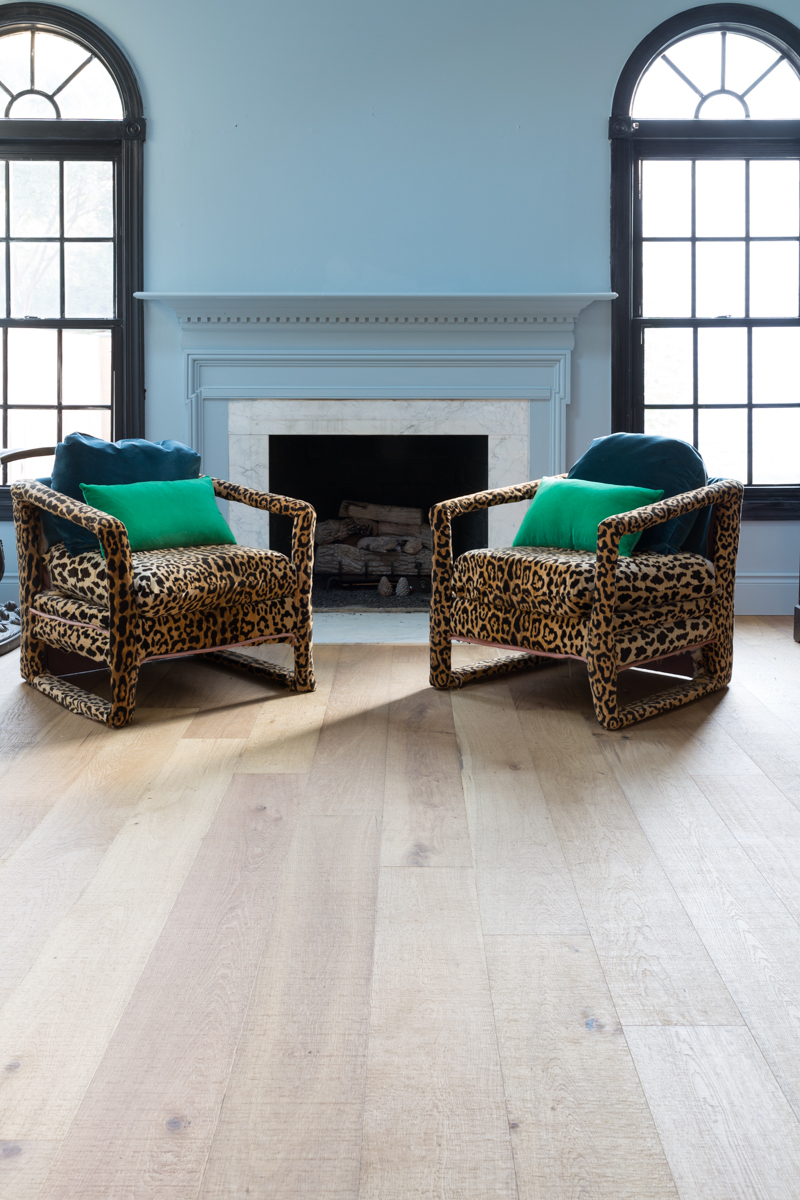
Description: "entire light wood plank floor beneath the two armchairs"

(0, 618), (800, 1200)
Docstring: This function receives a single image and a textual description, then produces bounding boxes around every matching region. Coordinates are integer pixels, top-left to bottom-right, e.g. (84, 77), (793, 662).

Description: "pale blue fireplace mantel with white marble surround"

(137, 292), (614, 547)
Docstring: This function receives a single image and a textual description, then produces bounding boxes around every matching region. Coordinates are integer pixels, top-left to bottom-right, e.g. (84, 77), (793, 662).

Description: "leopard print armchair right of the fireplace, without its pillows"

(431, 479), (744, 730)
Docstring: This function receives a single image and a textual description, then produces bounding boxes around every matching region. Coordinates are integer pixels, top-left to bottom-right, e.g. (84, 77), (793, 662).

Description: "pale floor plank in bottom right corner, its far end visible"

(626, 1027), (800, 1200)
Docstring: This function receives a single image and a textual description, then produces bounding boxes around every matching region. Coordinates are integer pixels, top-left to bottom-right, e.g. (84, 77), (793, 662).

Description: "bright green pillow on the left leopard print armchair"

(80, 475), (236, 550)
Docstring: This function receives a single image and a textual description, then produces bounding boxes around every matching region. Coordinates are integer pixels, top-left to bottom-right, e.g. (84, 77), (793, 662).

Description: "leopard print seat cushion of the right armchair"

(453, 546), (716, 617)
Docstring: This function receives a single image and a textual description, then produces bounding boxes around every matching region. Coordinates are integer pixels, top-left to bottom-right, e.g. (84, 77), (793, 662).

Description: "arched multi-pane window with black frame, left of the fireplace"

(0, 4), (145, 506)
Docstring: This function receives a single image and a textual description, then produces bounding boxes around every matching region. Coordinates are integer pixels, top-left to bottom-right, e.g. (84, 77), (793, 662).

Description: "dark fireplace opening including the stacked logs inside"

(270, 434), (488, 607)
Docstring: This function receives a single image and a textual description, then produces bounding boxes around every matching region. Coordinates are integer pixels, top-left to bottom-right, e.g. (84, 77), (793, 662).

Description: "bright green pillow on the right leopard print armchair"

(513, 479), (663, 558)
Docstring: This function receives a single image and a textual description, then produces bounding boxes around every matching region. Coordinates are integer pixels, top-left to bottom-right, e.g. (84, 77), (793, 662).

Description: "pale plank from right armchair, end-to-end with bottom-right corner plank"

(519, 708), (741, 1025)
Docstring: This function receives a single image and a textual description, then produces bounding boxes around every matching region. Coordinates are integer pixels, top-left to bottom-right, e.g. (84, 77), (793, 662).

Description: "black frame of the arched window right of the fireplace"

(608, 4), (800, 521)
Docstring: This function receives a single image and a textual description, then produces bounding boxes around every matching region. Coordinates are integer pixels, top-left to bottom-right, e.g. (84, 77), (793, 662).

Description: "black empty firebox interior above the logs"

(270, 434), (489, 554)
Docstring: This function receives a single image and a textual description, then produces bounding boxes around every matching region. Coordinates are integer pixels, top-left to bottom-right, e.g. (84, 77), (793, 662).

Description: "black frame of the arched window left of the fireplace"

(0, 2), (146, 521)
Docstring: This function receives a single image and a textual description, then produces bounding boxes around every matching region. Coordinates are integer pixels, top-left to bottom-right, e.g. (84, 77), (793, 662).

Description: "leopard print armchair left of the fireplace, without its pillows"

(11, 479), (317, 728)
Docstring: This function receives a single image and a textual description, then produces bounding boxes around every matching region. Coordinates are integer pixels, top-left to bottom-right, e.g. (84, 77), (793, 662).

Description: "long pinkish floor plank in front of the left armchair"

(34, 775), (306, 1200)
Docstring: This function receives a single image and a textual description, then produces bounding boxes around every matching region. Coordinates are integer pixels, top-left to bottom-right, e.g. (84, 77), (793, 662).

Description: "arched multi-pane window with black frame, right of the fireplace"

(609, 5), (800, 518)
